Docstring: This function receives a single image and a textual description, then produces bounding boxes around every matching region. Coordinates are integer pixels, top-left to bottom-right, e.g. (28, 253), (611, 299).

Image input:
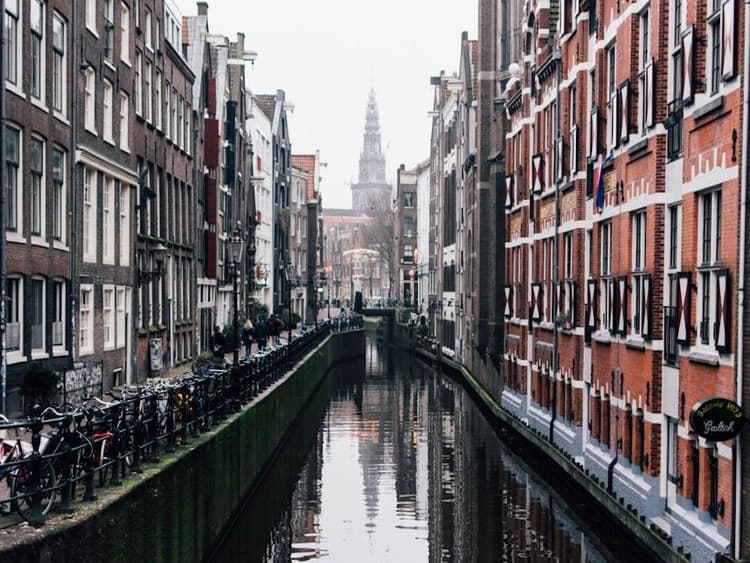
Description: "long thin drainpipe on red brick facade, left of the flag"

(549, 47), (562, 444)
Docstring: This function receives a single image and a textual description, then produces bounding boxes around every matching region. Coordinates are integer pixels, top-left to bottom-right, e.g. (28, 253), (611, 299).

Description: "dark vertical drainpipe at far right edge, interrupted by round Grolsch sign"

(731, 0), (750, 558)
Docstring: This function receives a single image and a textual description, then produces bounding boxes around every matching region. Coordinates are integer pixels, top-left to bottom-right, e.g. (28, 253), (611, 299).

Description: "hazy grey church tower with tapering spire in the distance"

(352, 89), (391, 213)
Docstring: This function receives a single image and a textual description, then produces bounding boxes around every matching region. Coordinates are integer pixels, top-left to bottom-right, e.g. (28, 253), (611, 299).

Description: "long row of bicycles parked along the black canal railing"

(0, 317), (362, 526)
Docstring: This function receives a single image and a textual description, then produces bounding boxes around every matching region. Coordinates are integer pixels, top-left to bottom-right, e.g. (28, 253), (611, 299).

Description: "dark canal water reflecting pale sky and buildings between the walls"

(210, 340), (646, 563)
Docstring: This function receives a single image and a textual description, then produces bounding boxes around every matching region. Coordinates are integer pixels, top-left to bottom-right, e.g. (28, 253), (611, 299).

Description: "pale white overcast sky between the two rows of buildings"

(177, 0), (478, 208)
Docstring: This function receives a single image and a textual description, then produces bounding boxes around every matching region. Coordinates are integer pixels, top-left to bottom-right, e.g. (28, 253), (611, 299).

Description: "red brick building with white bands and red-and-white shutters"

(500, 0), (742, 560)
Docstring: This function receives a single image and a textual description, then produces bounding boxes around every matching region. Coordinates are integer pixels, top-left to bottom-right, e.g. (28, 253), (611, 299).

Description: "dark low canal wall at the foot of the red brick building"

(395, 324), (690, 563)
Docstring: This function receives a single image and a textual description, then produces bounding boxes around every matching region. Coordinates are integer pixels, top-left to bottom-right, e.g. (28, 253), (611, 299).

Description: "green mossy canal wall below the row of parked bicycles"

(0, 330), (365, 563)
